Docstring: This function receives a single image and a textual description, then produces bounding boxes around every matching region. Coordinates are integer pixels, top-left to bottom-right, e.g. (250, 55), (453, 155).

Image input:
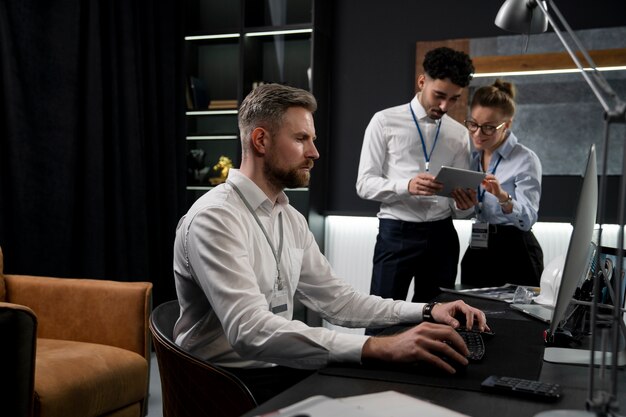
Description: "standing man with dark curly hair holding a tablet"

(356, 47), (474, 328)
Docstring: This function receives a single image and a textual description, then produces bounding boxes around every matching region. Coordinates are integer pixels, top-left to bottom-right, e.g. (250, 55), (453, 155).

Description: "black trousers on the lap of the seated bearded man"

(224, 366), (315, 404)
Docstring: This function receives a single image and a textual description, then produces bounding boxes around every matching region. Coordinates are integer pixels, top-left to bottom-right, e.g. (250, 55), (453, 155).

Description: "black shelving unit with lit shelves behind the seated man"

(180, 0), (329, 216)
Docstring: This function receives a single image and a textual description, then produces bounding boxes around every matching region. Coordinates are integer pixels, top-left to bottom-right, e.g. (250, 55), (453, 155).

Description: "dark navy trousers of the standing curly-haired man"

(370, 218), (460, 302)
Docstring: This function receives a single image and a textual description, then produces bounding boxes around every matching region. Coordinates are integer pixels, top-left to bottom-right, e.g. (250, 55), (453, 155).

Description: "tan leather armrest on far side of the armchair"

(4, 275), (152, 359)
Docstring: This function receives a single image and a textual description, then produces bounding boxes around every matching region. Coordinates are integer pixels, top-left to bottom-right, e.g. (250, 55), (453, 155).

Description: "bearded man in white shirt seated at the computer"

(174, 84), (488, 403)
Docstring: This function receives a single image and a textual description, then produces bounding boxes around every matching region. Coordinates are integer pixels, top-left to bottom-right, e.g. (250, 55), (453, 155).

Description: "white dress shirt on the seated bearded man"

(174, 169), (424, 368)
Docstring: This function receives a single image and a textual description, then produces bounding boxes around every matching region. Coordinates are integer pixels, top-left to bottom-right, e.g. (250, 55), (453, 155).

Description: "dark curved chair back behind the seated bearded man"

(150, 300), (257, 417)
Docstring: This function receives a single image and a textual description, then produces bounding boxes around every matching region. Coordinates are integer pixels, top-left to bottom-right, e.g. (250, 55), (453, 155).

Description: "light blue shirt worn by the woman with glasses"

(471, 132), (541, 231)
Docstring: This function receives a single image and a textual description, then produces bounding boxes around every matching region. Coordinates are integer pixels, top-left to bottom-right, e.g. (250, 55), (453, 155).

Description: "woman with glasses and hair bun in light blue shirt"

(453, 80), (543, 287)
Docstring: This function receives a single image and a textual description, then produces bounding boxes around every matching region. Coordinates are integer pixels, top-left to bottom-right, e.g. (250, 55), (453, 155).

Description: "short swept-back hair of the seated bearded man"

(238, 84), (317, 155)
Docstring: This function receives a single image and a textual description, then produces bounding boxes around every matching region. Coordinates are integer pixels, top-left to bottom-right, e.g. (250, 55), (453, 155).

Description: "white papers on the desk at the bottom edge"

(257, 391), (465, 417)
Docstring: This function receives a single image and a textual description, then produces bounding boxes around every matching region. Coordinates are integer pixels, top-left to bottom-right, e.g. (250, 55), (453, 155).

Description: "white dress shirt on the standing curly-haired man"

(356, 95), (470, 222)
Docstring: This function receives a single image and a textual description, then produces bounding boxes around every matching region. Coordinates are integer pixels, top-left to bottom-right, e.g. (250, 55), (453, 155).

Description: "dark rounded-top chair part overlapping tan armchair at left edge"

(0, 302), (37, 417)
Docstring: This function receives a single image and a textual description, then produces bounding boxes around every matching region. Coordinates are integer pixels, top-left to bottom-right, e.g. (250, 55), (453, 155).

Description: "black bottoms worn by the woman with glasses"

(461, 225), (543, 287)
